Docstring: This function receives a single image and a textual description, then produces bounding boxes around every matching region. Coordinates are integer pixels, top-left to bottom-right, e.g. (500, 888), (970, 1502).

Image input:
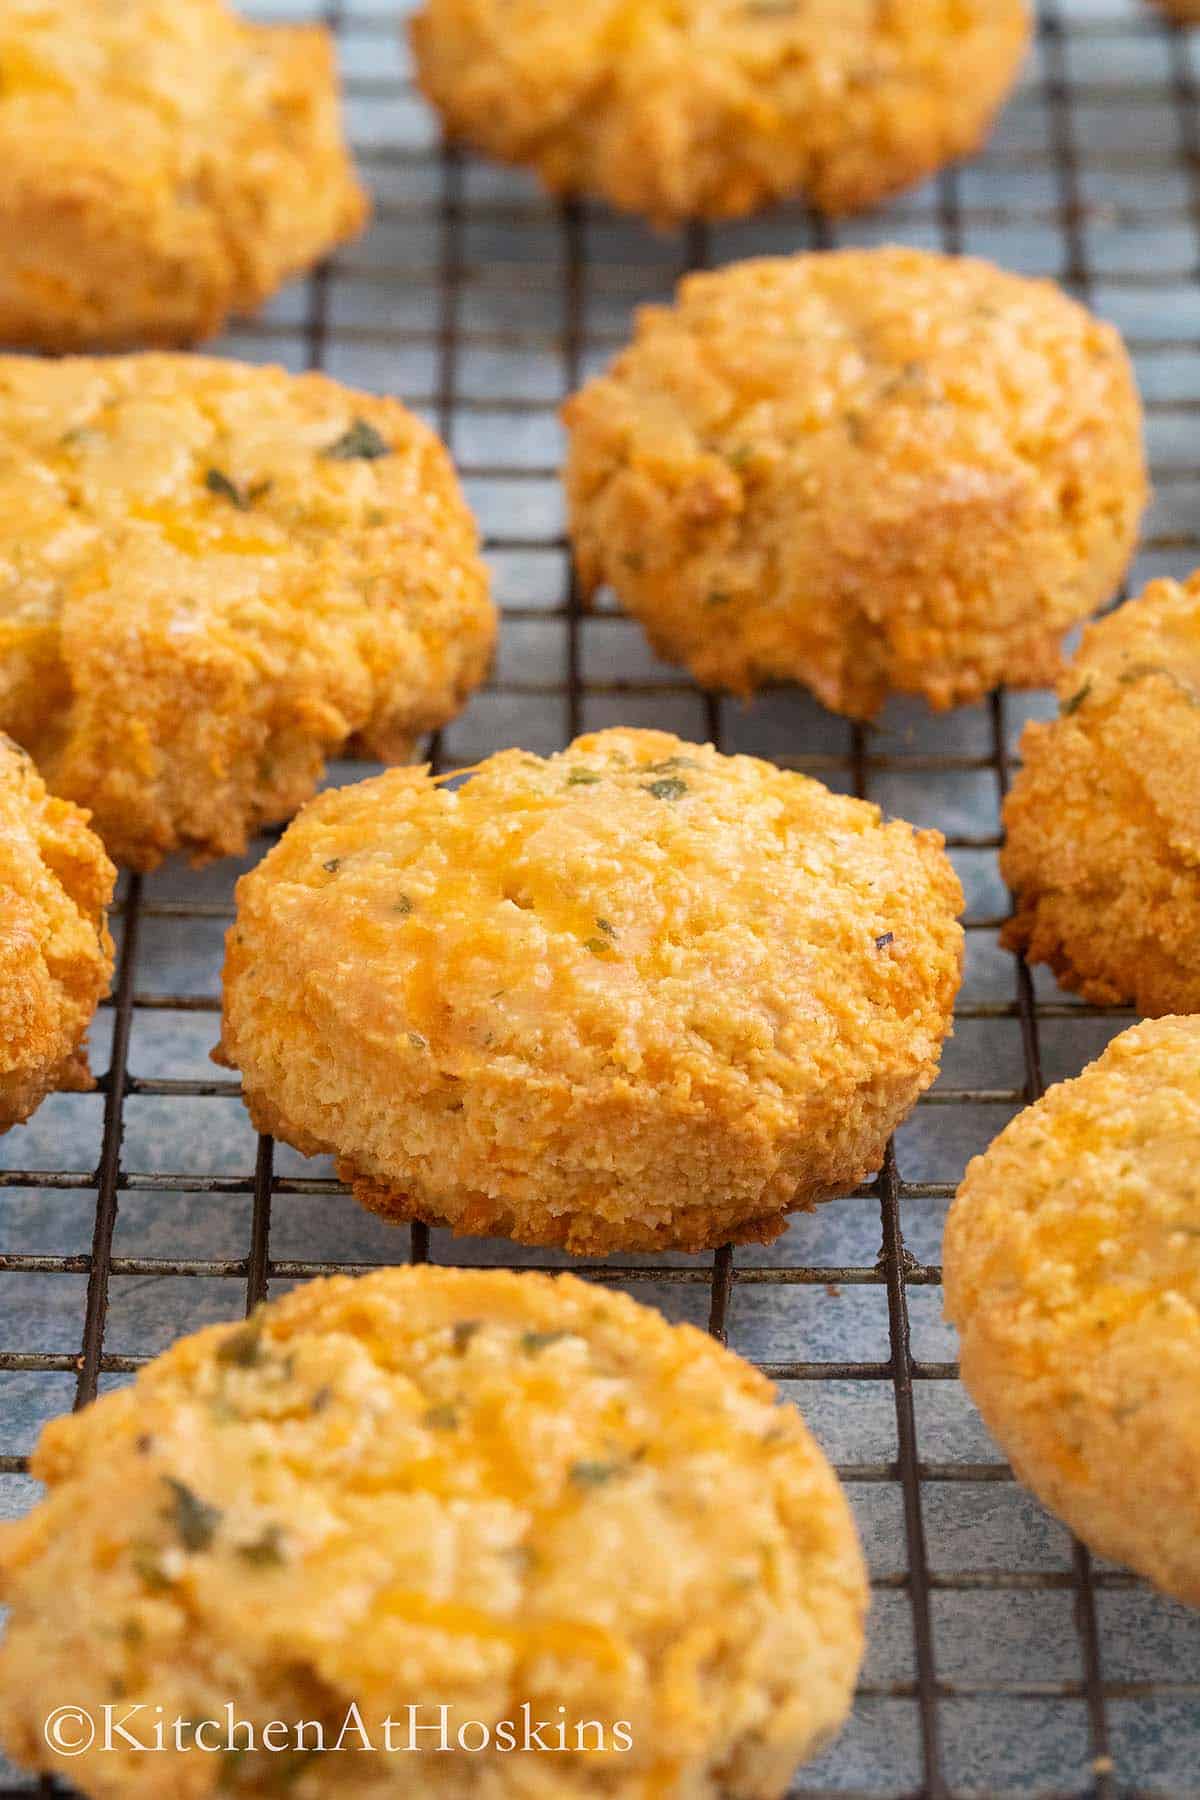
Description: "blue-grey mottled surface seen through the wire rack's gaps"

(0, 0), (1200, 1796)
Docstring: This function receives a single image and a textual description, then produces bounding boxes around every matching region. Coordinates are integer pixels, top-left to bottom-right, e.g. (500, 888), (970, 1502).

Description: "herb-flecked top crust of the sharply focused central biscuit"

(227, 729), (963, 1094)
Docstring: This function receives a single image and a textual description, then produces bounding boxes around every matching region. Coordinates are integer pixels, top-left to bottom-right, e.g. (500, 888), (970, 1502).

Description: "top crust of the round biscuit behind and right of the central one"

(567, 248), (1137, 525)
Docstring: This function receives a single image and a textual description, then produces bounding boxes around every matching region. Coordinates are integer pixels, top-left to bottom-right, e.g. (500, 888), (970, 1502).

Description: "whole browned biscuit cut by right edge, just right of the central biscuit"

(1000, 574), (1200, 1013)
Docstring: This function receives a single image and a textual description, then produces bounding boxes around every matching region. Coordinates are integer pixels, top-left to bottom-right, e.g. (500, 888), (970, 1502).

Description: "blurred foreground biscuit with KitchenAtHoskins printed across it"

(0, 1267), (867, 1800)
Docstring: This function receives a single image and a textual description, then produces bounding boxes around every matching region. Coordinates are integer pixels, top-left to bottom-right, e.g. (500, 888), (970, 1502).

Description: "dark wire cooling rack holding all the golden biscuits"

(0, 0), (1200, 1800)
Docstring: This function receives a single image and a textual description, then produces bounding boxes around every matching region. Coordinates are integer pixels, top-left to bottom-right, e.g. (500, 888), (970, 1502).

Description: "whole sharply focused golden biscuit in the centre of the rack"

(223, 731), (963, 1253)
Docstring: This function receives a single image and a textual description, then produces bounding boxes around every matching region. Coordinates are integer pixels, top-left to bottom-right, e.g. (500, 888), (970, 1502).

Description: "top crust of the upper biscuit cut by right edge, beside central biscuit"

(1052, 572), (1200, 869)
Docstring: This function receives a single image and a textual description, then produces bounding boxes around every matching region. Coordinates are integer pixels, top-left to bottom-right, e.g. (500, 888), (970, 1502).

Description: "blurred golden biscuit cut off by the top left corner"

(0, 0), (367, 351)
